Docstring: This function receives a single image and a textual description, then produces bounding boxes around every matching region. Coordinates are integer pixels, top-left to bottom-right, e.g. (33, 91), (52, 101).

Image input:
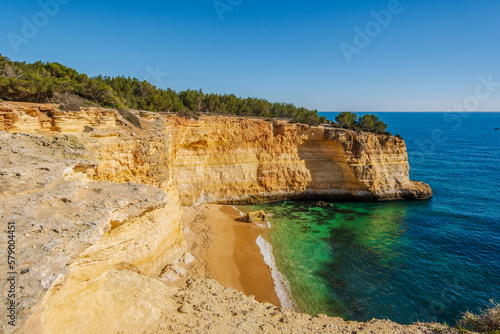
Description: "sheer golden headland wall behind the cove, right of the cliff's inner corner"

(163, 117), (432, 205)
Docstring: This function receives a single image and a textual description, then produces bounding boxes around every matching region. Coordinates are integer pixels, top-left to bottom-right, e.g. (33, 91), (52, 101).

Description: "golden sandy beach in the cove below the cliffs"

(183, 204), (280, 306)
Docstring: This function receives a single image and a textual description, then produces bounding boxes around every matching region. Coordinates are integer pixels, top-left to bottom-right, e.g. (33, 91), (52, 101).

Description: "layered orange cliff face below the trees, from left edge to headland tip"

(0, 104), (432, 205)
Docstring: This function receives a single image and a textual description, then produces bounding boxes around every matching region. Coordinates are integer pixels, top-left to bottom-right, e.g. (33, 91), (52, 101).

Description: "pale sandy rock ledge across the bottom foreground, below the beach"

(20, 269), (458, 334)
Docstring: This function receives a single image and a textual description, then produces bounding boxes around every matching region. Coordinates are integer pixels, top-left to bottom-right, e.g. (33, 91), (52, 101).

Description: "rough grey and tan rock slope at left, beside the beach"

(0, 105), (186, 333)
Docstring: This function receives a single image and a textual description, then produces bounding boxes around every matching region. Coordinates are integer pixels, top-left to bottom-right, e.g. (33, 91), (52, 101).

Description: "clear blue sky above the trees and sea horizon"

(0, 0), (500, 111)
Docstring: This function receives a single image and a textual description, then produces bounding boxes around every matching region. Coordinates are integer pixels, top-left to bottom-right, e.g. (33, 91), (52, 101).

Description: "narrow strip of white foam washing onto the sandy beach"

(255, 235), (296, 310)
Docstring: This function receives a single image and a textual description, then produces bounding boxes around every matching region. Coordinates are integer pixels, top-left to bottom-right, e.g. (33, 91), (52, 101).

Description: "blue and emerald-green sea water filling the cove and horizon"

(240, 113), (500, 324)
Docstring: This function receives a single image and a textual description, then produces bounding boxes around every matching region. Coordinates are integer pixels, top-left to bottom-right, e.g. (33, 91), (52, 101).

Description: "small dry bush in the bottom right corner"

(458, 301), (500, 334)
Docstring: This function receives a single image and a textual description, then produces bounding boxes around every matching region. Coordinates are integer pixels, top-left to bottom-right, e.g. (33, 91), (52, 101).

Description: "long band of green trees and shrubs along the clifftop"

(0, 54), (327, 125)
